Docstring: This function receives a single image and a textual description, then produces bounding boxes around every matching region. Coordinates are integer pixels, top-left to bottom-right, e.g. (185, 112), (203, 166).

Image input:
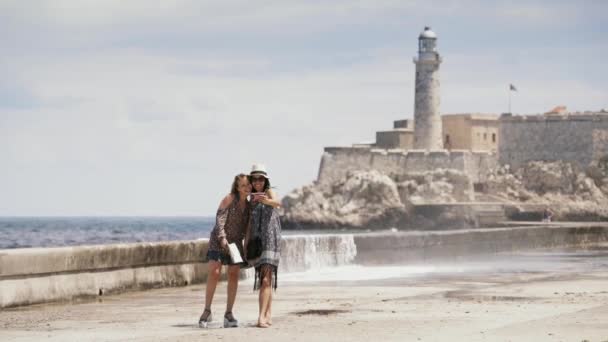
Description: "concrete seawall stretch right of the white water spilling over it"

(354, 223), (608, 265)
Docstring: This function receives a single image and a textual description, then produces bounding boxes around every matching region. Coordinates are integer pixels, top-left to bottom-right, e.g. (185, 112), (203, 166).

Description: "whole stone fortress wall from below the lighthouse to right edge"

(318, 112), (608, 187)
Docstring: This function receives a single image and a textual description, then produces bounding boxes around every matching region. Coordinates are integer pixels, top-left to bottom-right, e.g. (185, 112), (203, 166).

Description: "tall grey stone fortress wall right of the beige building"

(498, 113), (608, 168)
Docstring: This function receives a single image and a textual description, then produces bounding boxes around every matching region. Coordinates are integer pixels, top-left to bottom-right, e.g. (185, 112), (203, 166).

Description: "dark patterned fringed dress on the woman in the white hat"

(247, 203), (281, 290)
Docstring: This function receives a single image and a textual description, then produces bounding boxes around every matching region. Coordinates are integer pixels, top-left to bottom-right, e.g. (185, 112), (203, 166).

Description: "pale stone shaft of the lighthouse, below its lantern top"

(414, 60), (443, 150)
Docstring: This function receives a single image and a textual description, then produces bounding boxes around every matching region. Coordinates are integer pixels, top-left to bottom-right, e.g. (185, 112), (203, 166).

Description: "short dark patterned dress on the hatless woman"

(207, 195), (251, 267)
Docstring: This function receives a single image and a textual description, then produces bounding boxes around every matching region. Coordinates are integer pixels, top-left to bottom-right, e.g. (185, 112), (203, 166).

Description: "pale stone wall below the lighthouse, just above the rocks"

(318, 147), (497, 184)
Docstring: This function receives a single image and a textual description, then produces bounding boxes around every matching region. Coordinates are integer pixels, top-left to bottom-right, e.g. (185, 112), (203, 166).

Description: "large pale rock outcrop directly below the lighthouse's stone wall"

(282, 169), (473, 229)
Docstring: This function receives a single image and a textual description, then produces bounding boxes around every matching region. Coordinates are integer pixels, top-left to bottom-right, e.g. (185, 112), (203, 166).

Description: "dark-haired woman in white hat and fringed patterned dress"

(245, 164), (281, 328)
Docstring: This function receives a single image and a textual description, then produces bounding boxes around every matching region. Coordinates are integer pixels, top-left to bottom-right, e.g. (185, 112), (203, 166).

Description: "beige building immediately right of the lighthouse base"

(441, 114), (499, 151)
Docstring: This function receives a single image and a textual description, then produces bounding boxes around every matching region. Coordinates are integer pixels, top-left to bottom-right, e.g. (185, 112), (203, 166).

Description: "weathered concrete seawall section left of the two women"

(0, 240), (207, 307)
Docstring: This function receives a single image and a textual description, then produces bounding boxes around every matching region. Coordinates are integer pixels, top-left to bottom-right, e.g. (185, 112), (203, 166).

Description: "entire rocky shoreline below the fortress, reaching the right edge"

(282, 160), (608, 229)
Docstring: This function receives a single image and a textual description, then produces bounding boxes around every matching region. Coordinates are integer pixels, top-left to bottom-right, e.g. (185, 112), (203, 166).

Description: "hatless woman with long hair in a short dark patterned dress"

(198, 174), (251, 328)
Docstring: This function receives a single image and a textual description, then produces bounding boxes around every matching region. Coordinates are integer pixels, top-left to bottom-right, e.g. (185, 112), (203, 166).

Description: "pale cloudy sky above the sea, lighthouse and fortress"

(0, 0), (608, 216)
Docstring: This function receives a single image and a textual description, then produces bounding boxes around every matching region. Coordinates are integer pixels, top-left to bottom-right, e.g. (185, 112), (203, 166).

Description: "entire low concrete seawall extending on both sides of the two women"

(0, 224), (608, 308)
